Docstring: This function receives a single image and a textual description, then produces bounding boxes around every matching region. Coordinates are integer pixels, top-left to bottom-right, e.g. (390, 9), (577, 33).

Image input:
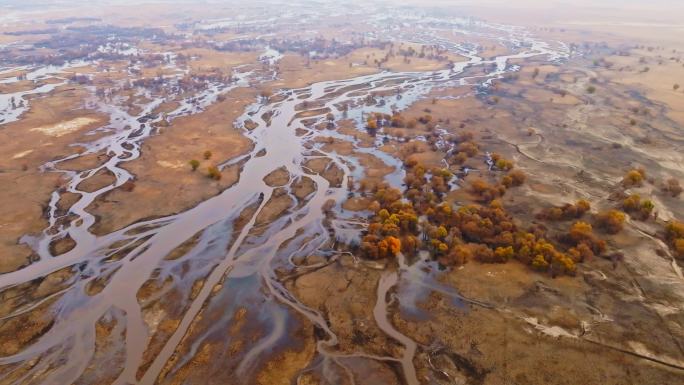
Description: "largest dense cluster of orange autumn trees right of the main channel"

(361, 161), (606, 275)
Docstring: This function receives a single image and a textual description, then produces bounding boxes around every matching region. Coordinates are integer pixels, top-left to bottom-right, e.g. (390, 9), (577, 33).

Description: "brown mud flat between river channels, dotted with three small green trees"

(88, 89), (256, 234)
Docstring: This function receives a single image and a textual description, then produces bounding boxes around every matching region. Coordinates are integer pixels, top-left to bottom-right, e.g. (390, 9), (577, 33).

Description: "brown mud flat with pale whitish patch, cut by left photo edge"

(0, 87), (108, 272)
